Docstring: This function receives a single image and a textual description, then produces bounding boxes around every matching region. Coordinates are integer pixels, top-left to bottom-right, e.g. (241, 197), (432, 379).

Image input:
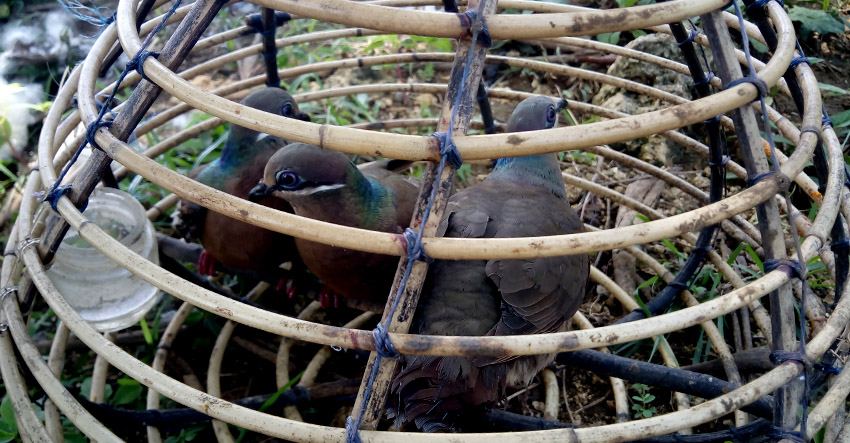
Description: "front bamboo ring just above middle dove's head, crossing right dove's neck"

(109, 1), (796, 163)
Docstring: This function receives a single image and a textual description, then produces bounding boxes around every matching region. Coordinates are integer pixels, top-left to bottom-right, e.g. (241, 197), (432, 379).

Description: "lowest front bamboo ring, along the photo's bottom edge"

(12, 255), (850, 443)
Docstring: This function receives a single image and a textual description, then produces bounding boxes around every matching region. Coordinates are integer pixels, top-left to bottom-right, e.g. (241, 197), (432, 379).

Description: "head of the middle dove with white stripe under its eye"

(249, 143), (352, 205)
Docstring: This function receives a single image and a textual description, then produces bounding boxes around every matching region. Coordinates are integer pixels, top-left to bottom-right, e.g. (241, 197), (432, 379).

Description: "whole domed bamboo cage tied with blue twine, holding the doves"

(0, 0), (850, 442)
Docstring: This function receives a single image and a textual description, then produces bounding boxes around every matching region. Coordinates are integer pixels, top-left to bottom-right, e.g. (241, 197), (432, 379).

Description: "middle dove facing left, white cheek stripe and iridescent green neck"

(251, 143), (419, 301)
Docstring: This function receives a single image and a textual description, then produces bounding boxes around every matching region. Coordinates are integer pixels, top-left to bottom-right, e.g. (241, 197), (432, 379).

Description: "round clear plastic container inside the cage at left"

(47, 188), (159, 332)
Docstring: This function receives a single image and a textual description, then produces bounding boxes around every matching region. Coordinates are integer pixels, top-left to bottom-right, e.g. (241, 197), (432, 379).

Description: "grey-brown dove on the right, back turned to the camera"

(388, 96), (589, 432)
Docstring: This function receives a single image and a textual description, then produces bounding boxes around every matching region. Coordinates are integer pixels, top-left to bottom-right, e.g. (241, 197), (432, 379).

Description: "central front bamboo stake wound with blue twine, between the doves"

(352, 0), (496, 429)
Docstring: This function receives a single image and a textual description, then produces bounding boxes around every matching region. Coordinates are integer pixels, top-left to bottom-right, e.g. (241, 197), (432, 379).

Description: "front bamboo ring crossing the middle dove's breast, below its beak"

(69, 18), (814, 259)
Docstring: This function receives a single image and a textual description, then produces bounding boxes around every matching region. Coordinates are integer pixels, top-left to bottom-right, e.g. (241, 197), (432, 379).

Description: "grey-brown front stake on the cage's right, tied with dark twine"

(702, 11), (802, 429)
